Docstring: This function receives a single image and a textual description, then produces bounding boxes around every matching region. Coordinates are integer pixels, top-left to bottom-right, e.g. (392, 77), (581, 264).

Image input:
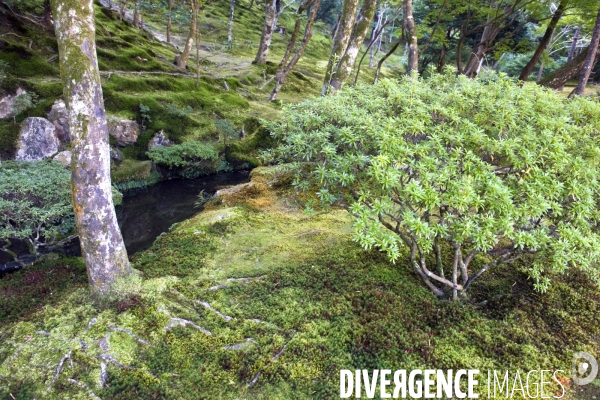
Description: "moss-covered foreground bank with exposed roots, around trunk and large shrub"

(0, 168), (600, 399)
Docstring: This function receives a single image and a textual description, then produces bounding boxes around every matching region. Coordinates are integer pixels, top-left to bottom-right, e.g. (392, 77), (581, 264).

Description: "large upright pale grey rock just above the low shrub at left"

(15, 117), (60, 161)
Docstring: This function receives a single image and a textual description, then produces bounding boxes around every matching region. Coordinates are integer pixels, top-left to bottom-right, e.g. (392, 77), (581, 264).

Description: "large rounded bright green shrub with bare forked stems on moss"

(268, 74), (600, 298)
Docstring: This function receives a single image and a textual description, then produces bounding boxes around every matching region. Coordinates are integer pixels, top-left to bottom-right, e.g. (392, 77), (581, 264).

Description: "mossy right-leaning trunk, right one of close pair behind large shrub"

(331, 0), (376, 90)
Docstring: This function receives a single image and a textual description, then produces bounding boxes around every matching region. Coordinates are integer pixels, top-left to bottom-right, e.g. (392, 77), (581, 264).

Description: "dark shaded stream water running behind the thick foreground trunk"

(0, 171), (249, 277)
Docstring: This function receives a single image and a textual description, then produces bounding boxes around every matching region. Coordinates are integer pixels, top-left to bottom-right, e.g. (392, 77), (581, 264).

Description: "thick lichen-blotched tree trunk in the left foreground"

(51, 0), (133, 296)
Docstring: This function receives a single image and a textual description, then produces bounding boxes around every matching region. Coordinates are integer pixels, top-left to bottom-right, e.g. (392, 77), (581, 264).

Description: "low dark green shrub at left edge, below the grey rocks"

(0, 161), (74, 260)
